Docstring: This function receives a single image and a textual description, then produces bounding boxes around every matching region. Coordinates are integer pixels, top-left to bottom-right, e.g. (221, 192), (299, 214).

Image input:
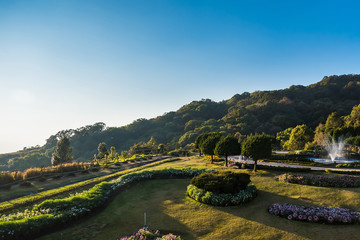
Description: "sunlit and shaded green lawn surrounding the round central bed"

(40, 158), (360, 240)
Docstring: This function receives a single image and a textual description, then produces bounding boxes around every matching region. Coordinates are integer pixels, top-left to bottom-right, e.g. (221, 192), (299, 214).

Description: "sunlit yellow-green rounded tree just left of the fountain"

(284, 124), (314, 150)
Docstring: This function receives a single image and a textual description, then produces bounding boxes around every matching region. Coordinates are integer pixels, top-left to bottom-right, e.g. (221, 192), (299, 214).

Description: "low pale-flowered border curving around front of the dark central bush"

(186, 184), (257, 206)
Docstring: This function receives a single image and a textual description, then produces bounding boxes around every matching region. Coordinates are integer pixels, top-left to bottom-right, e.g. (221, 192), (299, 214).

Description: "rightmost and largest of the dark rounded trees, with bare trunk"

(241, 134), (274, 172)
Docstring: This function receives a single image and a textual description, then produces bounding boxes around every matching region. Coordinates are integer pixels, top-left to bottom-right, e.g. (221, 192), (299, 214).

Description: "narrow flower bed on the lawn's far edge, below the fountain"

(277, 173), (360, 187)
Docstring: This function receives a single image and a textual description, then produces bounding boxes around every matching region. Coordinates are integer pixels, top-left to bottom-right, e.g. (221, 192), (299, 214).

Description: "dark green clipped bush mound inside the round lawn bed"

(191, 172), (250, 193)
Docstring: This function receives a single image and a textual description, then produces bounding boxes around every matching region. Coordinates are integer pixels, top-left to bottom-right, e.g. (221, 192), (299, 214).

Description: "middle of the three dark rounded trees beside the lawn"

(214, 136), (241, 167)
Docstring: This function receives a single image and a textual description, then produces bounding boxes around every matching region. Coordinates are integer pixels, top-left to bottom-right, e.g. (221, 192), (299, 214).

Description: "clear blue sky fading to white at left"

(0, 0), (360, 153)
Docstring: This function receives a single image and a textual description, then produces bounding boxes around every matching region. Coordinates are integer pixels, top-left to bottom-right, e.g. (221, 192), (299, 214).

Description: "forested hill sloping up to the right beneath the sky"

(0, 75), (360, 170)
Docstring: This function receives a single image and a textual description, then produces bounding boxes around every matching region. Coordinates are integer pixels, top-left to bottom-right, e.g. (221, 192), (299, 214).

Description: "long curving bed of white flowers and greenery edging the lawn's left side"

(0, 168), (211, 239)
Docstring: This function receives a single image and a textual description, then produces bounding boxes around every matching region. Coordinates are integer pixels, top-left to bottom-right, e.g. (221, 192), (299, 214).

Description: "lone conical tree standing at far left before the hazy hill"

(51, 136), (73, 166)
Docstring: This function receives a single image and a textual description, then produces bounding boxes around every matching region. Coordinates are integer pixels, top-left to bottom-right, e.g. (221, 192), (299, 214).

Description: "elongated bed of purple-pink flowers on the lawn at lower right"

(268, 203), (360, 224)
